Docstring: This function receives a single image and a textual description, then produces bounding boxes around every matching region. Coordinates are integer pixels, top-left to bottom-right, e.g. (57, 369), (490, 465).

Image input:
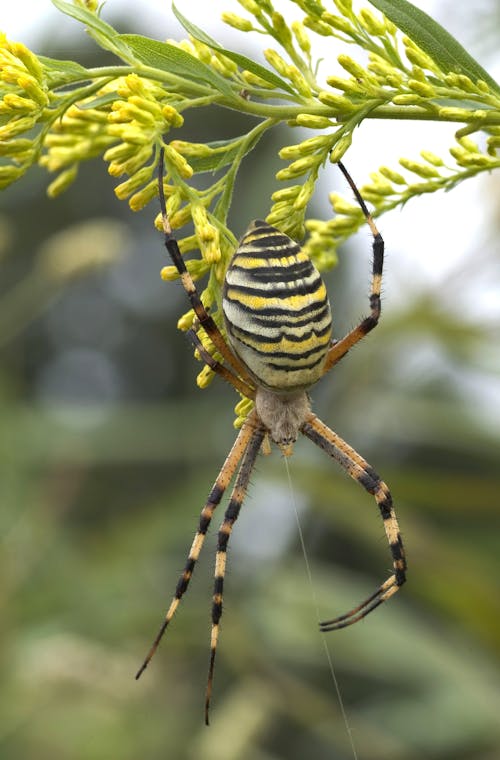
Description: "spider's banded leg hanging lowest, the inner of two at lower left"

(205, 425), (266, 726)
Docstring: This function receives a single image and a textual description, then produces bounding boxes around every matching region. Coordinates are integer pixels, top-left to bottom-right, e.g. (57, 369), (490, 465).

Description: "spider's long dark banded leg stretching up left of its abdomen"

(158, 148), (251, 383)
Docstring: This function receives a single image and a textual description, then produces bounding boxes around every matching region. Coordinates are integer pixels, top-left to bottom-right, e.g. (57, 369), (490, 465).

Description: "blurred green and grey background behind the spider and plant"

(0, 1), (500, 760)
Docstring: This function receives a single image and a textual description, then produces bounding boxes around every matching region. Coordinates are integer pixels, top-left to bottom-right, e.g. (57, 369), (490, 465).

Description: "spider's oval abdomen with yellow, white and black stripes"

(222, 221), (332, 393)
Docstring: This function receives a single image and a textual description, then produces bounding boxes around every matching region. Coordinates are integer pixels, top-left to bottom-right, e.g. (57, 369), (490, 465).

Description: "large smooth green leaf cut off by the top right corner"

(370, 0), (500, 92)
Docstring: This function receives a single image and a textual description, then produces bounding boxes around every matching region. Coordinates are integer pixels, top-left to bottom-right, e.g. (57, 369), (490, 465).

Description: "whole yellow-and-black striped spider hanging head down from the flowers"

(136, 150), (406, 725)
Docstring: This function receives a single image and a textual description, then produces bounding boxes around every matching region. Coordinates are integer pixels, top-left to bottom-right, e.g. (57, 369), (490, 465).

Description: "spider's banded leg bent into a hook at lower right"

(301, 414), (406, 632)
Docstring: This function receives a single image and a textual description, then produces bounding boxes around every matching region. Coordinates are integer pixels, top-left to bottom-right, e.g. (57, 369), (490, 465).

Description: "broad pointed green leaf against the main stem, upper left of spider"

(119, 34), (234, 97)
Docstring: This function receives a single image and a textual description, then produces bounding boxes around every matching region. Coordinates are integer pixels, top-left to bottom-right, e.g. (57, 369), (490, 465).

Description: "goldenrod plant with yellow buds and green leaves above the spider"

(0, 0), (500, 424)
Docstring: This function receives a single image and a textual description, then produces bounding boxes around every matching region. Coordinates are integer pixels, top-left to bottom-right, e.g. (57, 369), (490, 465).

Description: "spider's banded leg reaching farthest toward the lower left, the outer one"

(135, 412), (259, 679)
